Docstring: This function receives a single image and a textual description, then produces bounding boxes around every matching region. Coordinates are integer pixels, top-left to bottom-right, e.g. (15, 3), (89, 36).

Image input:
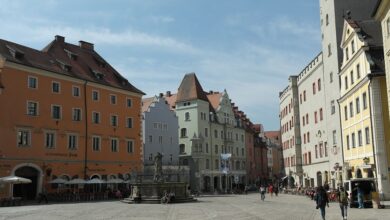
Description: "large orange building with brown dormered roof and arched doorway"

(0, 36), (143, 199)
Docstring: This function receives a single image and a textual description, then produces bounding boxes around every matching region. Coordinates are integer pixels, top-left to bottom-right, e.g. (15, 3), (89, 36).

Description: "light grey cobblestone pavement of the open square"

(0, 193), (390, 220)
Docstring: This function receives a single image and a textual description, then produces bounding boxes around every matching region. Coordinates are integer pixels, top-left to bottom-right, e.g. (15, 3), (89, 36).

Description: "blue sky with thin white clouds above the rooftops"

(0, 0), (321, 130)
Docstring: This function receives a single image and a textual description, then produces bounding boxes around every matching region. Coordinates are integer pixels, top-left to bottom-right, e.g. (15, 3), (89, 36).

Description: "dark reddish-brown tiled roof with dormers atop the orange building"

(0, 36), (144, 95)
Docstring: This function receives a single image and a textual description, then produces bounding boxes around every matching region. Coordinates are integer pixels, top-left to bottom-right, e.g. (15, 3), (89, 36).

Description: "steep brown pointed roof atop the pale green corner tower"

(176, 73), (208, 102)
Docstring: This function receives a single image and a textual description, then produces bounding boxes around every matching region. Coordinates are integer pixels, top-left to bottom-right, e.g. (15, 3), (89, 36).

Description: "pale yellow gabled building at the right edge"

(339, 19), (389, 196)
